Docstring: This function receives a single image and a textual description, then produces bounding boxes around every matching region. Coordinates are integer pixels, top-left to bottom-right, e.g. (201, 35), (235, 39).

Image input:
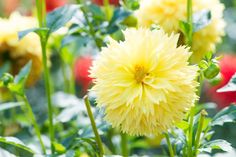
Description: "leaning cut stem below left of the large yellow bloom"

(84, 95), (104, 157)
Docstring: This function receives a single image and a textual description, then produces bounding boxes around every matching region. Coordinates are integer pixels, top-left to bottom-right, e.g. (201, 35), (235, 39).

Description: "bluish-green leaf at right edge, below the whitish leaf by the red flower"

(211, 105), (236, 126)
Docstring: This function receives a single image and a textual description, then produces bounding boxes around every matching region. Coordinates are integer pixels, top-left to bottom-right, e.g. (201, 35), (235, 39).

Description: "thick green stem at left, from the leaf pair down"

(41, 37), (54, 154)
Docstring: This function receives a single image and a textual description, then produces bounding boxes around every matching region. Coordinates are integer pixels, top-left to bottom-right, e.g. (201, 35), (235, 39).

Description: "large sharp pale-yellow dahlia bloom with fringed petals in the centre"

(90, 29), (198, 135)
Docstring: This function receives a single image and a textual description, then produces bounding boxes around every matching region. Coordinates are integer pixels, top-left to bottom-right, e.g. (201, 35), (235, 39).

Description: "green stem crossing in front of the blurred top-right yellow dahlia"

(187, 0), (193, 47)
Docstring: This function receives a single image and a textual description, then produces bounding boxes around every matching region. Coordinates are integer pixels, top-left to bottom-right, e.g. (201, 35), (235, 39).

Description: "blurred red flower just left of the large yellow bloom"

(74, 56), (92, 93)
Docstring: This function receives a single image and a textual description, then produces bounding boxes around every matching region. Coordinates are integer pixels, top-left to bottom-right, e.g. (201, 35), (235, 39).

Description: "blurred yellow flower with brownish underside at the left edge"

(0, 13), (42, 86)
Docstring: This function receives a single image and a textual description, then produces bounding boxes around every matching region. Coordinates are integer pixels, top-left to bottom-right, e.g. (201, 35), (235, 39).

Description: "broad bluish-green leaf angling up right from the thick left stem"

(47, 5), (79, 33)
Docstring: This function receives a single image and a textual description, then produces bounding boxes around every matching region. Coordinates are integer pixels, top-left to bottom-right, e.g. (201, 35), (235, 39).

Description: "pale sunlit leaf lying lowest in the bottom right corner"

(200, 139), (232, 153)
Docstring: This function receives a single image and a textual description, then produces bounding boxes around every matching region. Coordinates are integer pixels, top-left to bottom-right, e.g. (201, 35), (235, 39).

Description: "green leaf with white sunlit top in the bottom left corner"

(0, 137), (34, 157)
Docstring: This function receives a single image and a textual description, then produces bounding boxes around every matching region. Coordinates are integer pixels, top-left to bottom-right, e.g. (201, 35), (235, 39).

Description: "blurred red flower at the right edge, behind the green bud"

(208, 55), (236, 108)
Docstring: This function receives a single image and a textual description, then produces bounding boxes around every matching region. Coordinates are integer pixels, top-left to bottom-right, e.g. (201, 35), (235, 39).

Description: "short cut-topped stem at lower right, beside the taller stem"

(194, 110), (207, 157)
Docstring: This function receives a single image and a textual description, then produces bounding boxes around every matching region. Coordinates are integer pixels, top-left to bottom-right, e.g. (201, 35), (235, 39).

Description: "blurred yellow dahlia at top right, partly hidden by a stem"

(136, 0), (225, 63)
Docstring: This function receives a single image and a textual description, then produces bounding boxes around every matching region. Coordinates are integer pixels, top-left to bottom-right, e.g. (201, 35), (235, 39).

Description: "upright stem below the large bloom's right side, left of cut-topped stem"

(188, 107), (194, 157)
